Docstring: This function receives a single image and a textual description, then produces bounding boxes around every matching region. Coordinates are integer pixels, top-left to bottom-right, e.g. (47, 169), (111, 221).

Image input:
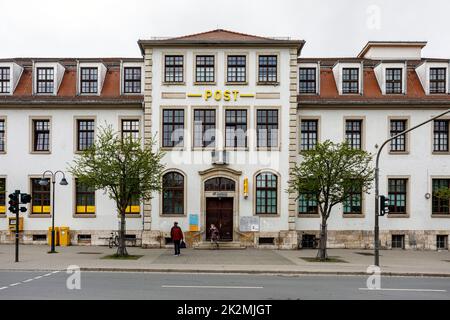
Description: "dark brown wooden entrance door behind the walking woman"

(206, 198), (233, 241)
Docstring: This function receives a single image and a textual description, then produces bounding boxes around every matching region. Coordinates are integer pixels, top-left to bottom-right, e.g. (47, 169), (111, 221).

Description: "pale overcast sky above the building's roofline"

(0, 0), (450, 58)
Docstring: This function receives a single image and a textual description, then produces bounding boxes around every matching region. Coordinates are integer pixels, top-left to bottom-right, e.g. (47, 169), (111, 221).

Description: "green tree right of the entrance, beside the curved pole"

(288, 140), (374, 260)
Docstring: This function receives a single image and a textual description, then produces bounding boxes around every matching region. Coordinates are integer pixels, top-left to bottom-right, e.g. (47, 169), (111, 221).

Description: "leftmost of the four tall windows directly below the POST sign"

(162, 109), (184, 148)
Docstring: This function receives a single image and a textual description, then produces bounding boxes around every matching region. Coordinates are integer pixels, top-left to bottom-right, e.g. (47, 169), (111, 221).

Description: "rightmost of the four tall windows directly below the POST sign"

(256, 110), (278, 148)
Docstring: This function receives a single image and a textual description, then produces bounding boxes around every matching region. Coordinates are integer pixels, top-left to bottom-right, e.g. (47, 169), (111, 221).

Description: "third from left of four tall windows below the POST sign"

(225, 109), (247, 148)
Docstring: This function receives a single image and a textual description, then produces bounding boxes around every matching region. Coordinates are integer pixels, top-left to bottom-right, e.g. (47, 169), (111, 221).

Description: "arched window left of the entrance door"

(162, 171), (184, 214)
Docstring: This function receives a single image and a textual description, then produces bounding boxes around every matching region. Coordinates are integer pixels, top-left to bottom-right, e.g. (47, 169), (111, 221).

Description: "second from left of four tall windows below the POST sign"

(194, 109), (216, 148)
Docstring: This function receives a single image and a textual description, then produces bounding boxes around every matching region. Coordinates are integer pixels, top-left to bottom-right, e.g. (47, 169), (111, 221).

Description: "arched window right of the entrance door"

(256, 172), (278, 214)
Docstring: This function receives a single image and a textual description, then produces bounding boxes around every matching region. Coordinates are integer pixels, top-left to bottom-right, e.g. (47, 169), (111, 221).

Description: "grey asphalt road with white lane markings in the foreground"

(0, 271), (450, 300)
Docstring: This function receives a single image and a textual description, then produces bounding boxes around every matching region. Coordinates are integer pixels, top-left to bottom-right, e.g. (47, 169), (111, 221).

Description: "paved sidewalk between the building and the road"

(0, 245), (450, 277)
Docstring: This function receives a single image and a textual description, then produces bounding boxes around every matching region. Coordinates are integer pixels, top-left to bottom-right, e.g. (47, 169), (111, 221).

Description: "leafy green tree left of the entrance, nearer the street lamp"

(69, 126), (164, 256)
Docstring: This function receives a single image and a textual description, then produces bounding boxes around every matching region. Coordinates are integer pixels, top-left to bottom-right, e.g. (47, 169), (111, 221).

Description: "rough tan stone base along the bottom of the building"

(0, 230), (450, 250)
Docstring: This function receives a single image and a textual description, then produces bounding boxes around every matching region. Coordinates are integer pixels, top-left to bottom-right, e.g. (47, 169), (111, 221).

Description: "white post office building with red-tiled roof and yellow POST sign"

(0, 30), (450, 249)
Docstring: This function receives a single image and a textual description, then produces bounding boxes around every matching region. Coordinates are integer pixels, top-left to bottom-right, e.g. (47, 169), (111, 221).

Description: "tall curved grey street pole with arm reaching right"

(374, 109), (450, 267)
